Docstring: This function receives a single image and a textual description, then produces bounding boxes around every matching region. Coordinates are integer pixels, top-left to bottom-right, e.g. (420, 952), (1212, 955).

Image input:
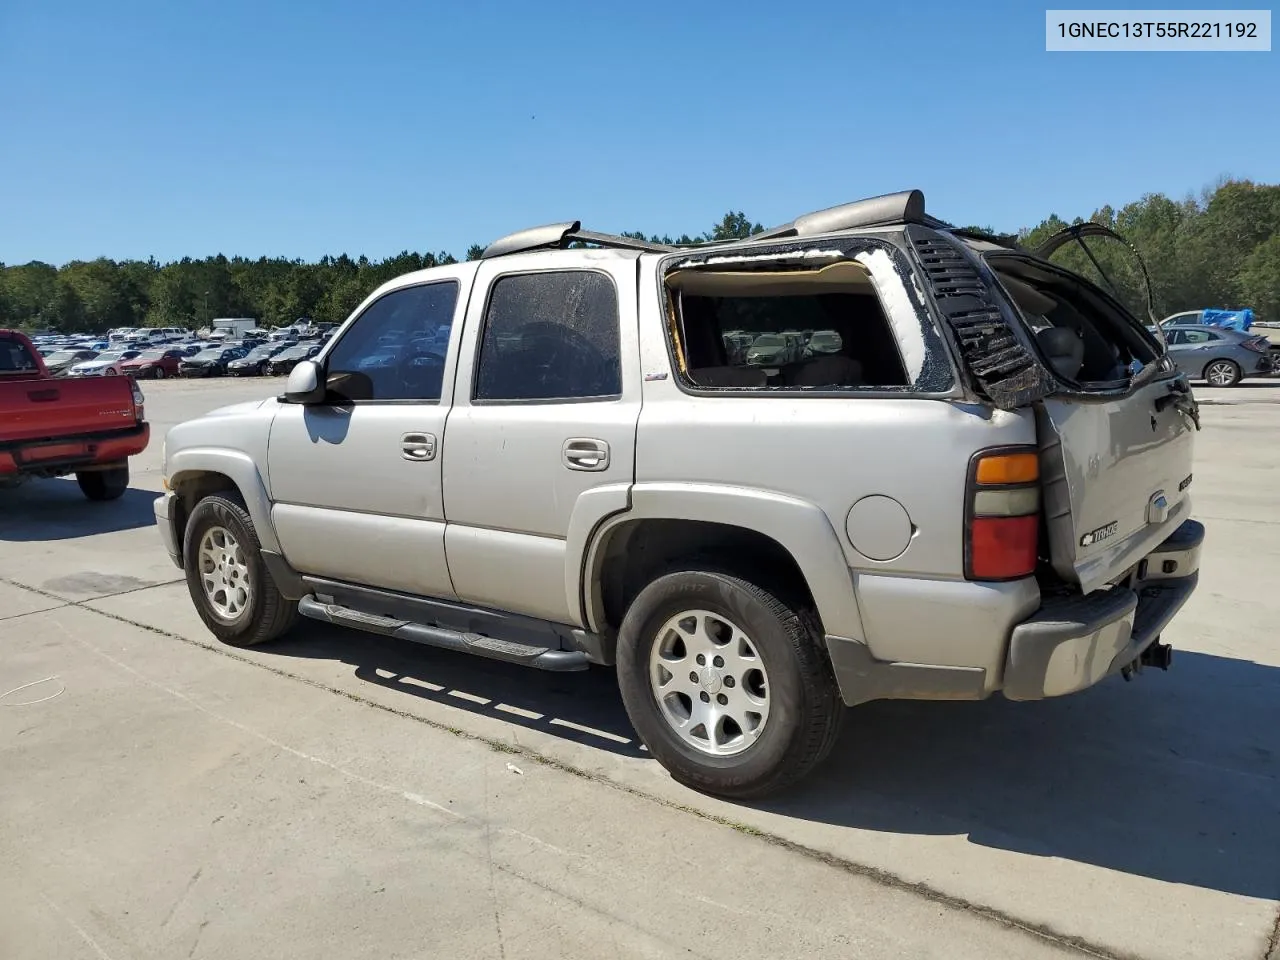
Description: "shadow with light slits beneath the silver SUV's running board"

(271, 621), (649, 758)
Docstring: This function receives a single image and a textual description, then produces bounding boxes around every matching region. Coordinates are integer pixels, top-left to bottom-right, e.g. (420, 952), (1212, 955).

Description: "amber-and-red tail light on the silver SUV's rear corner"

(964, 447), (1041, 580)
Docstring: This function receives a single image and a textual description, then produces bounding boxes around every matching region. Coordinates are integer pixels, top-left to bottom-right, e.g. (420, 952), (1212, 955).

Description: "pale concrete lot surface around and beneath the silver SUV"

(0, 380), (1280, 960)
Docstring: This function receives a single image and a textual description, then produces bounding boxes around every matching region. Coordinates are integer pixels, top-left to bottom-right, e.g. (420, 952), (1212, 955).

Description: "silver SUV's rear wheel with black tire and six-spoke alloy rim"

(617, 570), (845, 799)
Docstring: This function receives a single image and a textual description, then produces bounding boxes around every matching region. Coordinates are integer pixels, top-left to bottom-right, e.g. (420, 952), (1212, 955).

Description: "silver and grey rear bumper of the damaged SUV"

(1004, 520), (1204, 700)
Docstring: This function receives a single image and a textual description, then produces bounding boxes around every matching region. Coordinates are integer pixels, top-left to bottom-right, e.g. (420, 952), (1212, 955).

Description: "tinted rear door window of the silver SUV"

(475, 270), (622, 401)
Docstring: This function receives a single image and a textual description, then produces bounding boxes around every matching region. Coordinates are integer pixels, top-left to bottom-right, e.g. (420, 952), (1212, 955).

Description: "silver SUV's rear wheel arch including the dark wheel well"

(571, 484), (863, 650)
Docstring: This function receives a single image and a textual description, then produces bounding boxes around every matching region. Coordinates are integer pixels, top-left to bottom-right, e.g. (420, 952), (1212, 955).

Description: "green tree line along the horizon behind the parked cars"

(0, 180), (1280, 333)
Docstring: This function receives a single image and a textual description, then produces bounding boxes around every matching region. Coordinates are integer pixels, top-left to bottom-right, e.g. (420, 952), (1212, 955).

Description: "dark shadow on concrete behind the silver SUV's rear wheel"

(756, 652), (1280, 909)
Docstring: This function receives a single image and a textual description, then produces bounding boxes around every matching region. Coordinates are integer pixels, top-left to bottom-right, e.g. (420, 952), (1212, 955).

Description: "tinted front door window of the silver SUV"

(325, 280), (458, 401)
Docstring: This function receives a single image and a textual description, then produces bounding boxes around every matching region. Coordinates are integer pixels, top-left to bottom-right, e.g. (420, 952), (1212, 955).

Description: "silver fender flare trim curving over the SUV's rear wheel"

(576, 483), (864, 647)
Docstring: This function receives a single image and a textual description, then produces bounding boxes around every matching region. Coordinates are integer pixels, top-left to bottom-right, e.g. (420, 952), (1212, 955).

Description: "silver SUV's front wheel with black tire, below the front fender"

(183, 493), (298, 646)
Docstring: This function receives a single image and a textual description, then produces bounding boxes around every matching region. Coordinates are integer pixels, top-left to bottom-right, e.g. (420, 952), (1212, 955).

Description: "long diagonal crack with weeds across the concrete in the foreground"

(0, 577), (1177, 960)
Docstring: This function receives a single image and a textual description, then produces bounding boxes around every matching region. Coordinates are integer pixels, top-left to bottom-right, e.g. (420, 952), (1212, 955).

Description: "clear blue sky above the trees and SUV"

(0, 0), (1280, 264)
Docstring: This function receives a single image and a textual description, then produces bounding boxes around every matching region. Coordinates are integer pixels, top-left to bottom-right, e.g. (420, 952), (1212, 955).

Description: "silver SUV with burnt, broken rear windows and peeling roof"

(155, 191), (1203, 797)
